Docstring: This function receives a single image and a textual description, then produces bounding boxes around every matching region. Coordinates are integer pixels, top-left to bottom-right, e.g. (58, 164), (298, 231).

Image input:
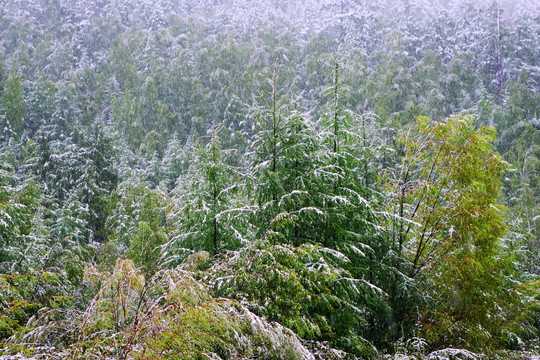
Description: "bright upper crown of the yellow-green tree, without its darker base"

(397, 116), (507, 275)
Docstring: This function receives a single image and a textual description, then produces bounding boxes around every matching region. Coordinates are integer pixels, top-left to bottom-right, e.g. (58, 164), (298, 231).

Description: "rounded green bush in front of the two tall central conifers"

(213, 241), (384, 358)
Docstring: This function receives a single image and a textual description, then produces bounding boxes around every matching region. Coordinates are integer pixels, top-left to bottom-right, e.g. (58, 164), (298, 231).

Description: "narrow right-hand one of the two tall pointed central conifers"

(319, 63), (377, 248)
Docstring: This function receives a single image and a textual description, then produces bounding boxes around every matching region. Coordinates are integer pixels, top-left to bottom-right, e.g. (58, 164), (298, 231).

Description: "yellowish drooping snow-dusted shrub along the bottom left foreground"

(48, 259), (314, 360)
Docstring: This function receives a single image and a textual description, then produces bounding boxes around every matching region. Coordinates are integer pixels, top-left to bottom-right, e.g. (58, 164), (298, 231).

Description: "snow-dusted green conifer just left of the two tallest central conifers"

(163, 127), (246, 266)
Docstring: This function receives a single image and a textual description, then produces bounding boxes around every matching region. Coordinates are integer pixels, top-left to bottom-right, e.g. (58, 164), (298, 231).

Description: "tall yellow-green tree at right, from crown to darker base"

(396, 116), (512, 349)
